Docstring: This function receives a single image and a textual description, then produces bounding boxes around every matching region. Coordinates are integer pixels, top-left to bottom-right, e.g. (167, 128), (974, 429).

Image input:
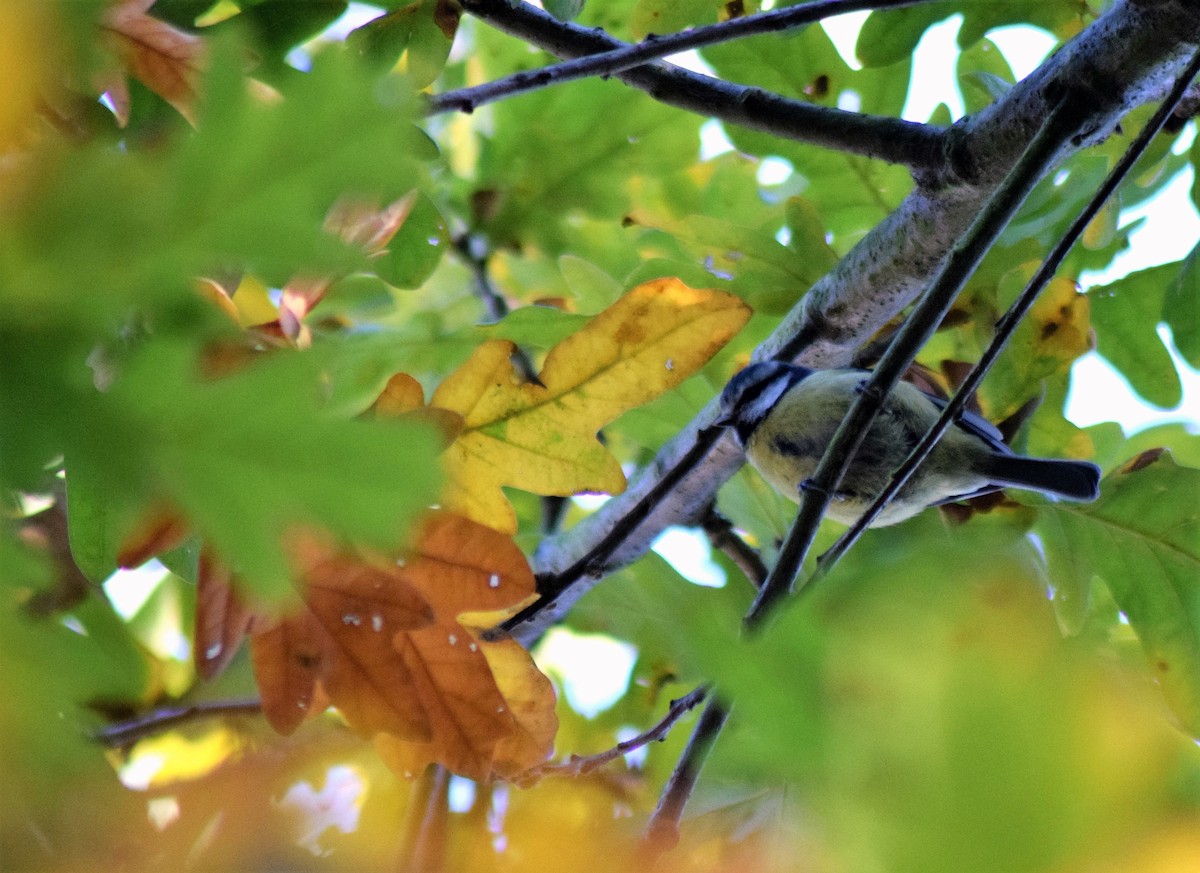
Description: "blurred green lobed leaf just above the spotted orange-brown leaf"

(67, 344), (439, 598)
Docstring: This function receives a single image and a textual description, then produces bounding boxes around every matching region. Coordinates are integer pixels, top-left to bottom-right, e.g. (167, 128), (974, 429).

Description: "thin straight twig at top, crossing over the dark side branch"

(428, 0), (929, 113)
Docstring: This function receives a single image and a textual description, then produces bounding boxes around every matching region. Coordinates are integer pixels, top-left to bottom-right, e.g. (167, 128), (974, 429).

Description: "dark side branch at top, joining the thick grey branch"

(451, 0), (946, 174)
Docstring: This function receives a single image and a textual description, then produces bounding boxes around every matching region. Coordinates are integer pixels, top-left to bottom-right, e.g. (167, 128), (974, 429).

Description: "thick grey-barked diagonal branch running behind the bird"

(517, 0), (1200, 642)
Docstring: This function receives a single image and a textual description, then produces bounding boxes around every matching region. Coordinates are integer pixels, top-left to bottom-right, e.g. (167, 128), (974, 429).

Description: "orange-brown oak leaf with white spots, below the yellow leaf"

(252, 508), (557, 779)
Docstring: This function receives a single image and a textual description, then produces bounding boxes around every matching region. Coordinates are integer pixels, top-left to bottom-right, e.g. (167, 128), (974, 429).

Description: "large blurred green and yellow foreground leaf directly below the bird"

(696, 518), (1181, 873)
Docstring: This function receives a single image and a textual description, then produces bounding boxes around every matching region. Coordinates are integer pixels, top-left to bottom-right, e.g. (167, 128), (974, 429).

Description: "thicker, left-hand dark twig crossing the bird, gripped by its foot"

(745, 98), (1081, 628)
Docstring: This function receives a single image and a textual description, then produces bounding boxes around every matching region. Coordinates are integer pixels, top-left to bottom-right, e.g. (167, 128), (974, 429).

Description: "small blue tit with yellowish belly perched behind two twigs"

(718, 361), (1100, 526)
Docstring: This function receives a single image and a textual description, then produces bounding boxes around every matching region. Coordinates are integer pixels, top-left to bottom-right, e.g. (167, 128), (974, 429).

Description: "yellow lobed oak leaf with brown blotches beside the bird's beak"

(431, 278), (750, 534)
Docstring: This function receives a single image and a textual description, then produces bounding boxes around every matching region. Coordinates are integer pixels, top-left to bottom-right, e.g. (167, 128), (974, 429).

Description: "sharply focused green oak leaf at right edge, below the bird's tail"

(1037, 453), (1200, 734)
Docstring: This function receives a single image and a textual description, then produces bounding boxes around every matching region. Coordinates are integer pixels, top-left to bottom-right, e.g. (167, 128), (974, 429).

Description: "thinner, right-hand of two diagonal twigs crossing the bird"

(810, 52), (1200, 584)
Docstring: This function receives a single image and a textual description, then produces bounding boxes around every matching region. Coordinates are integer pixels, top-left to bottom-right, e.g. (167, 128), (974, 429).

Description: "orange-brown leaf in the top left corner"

(103, 0), (204, 125)
